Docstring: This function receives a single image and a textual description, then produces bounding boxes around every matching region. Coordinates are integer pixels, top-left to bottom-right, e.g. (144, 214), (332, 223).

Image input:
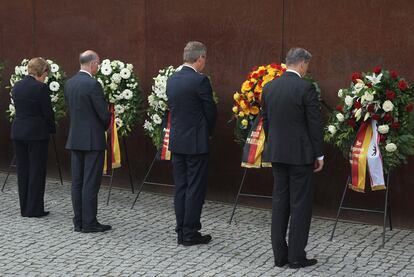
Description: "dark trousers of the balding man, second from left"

(71, 150), (104, 227)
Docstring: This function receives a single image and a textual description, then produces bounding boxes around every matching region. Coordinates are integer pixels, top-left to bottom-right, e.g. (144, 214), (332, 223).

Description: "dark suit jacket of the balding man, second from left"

(65, 72), (111, 151)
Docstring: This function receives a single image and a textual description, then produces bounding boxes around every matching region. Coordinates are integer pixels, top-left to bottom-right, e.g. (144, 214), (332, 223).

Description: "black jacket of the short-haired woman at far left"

(11, 75), (56, 140)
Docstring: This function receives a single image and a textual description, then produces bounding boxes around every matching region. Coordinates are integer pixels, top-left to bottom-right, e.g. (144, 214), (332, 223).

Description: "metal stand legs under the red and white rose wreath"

(329, 173), (392, 248)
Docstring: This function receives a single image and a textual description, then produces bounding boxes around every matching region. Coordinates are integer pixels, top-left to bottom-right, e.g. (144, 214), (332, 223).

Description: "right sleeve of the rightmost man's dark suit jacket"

(304, 84), (323, 159)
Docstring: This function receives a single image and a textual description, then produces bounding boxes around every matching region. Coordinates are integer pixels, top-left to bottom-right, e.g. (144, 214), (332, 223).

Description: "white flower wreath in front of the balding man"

(96, 59), (144, 136)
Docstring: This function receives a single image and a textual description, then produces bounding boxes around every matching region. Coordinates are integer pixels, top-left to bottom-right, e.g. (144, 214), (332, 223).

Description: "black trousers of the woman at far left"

(13, 140), (49, 217)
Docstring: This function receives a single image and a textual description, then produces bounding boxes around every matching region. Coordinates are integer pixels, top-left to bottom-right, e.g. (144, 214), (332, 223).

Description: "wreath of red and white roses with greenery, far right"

(325, 67), (414, 172)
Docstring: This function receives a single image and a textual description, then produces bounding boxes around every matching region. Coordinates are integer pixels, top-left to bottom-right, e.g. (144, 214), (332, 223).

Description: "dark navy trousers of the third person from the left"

(172, 153), (208, 239)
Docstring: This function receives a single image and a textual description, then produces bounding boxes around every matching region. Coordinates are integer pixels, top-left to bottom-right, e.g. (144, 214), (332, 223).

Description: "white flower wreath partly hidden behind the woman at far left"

(6, 59), (66, 122)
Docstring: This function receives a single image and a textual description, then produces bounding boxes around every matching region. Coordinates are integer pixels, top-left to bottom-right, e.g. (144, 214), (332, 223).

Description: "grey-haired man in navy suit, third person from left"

(167, 41), (217, 246)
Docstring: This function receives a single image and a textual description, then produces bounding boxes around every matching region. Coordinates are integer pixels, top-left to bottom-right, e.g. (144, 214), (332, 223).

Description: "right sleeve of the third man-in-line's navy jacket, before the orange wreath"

(199, 77), (217, 135)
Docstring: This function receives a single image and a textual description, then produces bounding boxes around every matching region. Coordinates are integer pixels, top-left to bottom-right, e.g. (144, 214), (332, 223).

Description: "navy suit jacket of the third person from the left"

(167, 66), (217, 154)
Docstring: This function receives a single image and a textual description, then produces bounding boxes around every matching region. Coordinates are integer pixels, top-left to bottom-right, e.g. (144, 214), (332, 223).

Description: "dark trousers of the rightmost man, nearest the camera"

(272, 163), (313, 262)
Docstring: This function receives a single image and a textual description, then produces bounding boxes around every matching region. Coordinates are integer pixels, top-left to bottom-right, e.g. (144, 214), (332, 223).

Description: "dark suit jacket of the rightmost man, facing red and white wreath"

(262, 72), (323, 165)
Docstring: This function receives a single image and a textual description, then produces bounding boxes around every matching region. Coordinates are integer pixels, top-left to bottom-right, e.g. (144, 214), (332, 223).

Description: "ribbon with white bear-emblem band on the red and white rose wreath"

(349, 120), (385, 192)
